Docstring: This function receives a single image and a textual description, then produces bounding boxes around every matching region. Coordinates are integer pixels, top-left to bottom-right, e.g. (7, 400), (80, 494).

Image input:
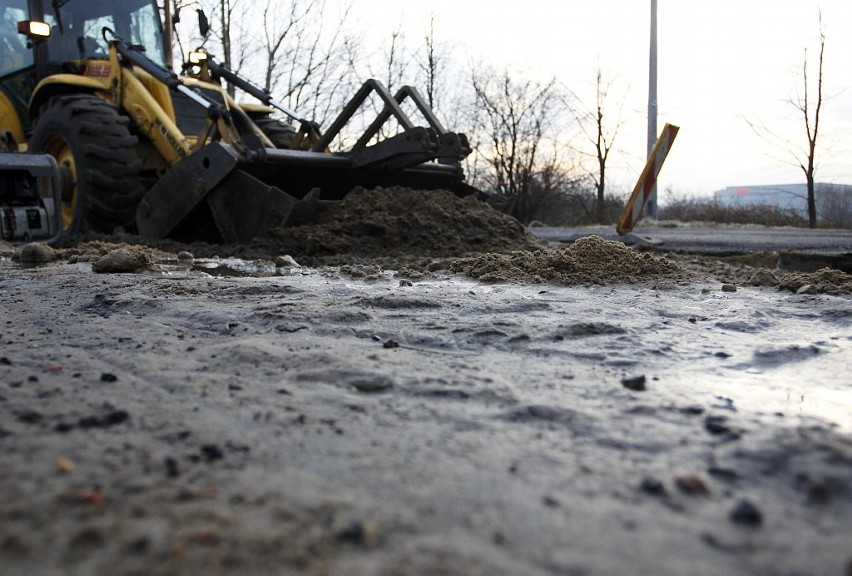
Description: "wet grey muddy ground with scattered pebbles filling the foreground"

(0, 191), (852, 576)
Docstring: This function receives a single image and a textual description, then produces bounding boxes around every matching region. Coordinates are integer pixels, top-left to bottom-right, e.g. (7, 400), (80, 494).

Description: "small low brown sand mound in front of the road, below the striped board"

(450, 236), (689, 285)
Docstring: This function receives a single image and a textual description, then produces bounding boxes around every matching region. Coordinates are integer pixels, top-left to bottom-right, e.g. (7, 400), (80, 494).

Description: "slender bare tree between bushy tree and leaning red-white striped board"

(568, 67), (624, 224)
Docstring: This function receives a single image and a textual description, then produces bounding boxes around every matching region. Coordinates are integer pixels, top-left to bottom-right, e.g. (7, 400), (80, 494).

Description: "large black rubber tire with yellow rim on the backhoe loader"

(30, 94), (146, 235)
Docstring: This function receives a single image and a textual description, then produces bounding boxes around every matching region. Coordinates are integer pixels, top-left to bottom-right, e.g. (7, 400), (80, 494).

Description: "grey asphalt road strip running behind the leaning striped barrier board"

(530, 225), (852, 273)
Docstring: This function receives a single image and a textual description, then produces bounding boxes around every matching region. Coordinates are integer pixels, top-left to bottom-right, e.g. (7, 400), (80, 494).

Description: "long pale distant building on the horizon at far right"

(713, 182), (852, 218)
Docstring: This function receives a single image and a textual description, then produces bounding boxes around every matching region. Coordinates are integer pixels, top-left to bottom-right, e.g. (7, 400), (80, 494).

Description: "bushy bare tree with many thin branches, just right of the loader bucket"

(472, 68), (559, 223)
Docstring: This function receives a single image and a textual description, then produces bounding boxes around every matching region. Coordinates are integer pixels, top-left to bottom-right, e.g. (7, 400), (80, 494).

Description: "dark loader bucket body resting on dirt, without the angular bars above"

(136, 143), (475, 243)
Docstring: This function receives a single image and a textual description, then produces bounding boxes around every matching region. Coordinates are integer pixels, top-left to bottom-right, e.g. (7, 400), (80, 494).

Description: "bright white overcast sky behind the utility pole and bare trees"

(336, 0), (852, 201)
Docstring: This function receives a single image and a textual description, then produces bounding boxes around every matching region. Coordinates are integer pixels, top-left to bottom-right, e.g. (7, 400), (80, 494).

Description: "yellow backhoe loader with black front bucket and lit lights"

(0, 0), (475, 242)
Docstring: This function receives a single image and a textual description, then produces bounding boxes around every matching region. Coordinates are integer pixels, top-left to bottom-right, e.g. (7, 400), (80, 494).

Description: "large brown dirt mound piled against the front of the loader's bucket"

(51, 188), (541, 267)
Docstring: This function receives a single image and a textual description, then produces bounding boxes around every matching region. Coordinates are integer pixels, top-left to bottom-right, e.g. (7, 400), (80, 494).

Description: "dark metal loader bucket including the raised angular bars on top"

(136, 80), (478, 243)
